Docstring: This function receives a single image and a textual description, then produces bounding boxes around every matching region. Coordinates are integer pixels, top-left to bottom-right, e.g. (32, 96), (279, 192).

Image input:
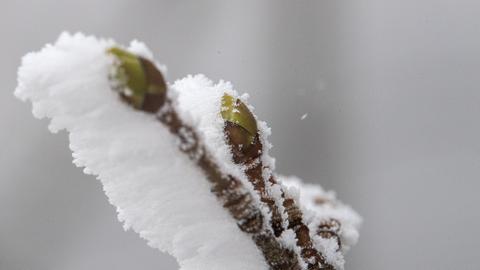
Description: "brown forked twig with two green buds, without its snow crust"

(109, 48), (340, 270)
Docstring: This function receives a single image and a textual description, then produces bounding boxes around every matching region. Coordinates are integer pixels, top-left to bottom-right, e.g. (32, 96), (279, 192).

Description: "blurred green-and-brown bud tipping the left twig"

(107, 47), (167, 112)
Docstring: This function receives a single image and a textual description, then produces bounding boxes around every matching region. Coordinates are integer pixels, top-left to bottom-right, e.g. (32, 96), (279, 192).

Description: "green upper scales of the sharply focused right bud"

(221, 94), (258, 144)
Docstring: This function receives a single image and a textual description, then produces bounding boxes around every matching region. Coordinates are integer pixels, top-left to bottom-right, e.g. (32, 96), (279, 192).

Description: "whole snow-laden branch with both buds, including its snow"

(15, 34), (360, 269)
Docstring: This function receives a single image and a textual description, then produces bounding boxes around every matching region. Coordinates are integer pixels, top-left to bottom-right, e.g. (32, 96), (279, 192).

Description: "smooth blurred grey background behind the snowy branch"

(0, 0), (480, 270)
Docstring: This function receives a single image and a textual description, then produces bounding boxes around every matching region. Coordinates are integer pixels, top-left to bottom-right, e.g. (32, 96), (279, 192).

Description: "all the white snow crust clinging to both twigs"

(15, 33), (361, 270)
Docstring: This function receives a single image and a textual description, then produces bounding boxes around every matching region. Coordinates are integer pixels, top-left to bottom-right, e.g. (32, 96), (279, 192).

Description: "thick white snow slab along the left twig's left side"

(15, 33), (267, 270)
